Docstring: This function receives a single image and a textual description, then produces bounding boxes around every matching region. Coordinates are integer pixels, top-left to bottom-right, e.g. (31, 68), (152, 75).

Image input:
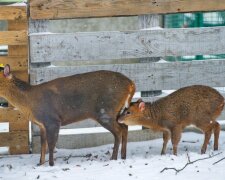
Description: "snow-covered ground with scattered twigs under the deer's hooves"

(0, 131), (225, 180)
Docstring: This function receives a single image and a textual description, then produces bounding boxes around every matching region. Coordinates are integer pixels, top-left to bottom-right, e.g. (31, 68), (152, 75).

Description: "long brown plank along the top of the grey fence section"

(30, 0), (225, 19)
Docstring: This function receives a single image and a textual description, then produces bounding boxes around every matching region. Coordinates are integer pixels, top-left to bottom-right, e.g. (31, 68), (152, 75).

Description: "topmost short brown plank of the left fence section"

(0, 5), (27, 21)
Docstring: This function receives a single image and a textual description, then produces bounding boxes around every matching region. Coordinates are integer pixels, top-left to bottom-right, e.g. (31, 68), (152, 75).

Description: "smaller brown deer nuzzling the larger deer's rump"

(118, 85), (224, 155)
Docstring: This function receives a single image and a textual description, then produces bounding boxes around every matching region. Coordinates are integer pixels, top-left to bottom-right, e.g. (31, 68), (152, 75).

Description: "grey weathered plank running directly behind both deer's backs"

(30, 60), (225, 91)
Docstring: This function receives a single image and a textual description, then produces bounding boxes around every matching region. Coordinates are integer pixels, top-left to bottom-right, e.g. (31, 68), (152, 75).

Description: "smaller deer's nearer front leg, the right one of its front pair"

(171, 126), (182, 155)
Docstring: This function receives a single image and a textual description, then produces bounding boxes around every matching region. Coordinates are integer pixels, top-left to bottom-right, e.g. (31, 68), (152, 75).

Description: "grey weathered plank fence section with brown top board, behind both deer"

(29, 0), (225, 152)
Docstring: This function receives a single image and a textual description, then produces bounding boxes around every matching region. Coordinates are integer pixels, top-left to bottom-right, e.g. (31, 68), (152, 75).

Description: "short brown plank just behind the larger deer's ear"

(0, 56), (28, 71)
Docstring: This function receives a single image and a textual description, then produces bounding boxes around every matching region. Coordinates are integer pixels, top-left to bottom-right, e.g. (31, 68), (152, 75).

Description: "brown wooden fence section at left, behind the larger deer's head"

(0, 6), (30, 154)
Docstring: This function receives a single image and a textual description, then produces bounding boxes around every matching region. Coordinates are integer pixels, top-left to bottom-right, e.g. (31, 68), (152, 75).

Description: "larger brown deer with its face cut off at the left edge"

(0, 65), (135, 166)
